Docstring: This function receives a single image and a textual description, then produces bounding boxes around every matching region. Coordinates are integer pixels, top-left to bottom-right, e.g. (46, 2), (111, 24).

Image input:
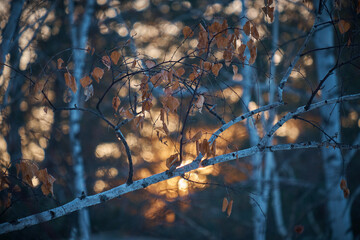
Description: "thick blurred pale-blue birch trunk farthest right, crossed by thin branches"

(314, 1), (352, 240)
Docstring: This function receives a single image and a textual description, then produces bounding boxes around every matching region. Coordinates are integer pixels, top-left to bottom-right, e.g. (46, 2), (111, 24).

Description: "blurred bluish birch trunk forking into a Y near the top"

(69, 0), (94, 239)
